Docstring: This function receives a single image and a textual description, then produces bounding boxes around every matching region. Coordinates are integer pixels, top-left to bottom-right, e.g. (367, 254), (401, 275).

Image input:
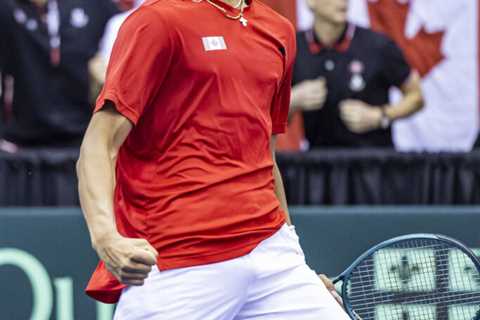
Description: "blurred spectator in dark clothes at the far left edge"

(0, 0), (118, 146)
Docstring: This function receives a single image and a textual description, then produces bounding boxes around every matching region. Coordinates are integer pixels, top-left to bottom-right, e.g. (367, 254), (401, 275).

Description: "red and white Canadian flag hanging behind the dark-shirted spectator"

(299, 0), (480, 151)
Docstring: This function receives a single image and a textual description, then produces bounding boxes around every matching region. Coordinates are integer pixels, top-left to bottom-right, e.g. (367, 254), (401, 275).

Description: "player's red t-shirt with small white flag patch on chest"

(87, 0), (295, 303)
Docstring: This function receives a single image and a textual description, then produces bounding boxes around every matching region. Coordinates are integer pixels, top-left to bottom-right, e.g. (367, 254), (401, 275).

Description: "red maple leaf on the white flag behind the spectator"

(368, 0), (445, 77)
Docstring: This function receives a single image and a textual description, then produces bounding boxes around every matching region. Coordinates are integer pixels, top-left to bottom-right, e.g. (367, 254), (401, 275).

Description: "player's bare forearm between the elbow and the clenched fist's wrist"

(77, 146), (117, 246)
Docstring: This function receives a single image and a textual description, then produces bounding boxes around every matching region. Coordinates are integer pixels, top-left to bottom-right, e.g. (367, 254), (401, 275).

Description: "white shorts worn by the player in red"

(114, 225), (350, 320)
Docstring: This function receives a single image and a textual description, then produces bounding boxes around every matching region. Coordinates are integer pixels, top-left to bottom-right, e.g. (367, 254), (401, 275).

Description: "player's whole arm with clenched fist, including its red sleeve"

(77, 6), (176, 285)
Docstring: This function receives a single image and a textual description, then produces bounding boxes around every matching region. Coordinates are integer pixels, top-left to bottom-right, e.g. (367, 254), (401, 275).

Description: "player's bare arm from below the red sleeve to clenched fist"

(77, 102), (158, 285)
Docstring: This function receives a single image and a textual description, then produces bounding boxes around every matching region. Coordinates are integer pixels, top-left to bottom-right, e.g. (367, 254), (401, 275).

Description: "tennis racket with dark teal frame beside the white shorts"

(333, 234), (480, 320)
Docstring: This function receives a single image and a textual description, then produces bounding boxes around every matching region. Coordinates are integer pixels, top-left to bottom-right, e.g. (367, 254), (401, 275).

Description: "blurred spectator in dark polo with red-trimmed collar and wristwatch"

(291, 0), (423, 147)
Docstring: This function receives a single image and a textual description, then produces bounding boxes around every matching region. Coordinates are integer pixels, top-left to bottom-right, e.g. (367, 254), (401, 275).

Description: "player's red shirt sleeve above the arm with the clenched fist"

(95, 7), (174, 124)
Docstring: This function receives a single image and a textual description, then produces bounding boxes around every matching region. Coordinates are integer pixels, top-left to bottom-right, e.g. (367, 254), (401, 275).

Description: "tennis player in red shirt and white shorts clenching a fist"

(78, 0), (348, 320)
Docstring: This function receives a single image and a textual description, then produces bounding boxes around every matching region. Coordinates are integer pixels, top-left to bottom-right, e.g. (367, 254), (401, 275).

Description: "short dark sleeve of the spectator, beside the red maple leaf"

(382, 39), (411, 87)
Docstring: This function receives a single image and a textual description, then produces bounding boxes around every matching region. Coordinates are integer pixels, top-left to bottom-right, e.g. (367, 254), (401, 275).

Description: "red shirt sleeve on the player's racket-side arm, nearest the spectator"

(271, 27), (296, 135)
